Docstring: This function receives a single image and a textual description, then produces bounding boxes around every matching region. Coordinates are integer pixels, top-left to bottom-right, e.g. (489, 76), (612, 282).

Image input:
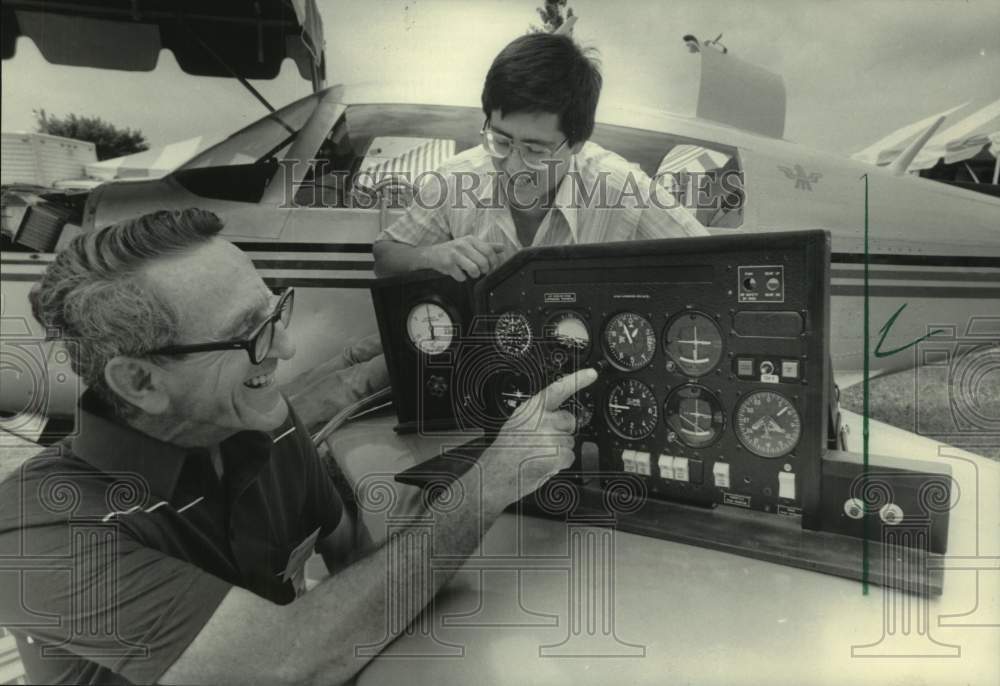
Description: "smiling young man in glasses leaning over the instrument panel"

(374, 33), (707, 281)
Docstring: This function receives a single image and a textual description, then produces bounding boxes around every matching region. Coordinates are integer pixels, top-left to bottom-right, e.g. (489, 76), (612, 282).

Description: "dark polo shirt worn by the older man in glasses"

(0, 393), (342, 684)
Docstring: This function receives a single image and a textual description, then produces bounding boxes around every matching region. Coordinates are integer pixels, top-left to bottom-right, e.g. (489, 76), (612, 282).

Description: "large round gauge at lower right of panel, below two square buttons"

(734, 391), (802, 458)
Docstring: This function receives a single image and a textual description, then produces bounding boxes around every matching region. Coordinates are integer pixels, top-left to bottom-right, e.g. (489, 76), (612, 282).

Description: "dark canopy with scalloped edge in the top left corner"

(0, 0), (326, 90)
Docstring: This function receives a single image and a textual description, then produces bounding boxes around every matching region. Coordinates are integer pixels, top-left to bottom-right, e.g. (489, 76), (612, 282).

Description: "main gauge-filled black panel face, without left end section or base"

(472, 231), (830, 515)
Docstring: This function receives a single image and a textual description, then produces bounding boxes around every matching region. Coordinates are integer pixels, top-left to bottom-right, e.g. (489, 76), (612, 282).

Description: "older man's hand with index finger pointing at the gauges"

(479, 369), (597, 510)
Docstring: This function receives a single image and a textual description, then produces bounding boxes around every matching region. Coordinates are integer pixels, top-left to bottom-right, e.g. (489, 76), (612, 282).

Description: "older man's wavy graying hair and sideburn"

(29, 209), (223, 418)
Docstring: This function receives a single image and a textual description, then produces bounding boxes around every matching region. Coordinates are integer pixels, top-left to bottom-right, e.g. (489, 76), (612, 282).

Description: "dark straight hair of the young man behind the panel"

(482, 33), (602, 145)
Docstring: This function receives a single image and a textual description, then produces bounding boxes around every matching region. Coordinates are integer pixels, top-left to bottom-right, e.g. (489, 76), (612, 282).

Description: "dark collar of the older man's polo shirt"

(73, 391), (282, 500)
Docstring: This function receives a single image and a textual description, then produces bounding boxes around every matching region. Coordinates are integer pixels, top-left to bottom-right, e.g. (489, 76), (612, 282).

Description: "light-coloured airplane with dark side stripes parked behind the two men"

(0, 0), (1000, 446)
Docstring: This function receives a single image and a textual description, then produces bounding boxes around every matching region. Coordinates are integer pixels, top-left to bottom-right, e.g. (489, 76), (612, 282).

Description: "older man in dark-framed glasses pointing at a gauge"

(0, 210), (596, 684)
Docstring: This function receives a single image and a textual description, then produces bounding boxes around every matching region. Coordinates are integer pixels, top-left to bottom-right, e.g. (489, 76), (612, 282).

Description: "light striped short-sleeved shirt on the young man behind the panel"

(375, 142), (708, 259)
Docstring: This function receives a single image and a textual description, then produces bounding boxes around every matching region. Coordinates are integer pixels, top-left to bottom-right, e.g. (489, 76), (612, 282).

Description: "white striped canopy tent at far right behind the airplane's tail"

(852, 99), (1000, 183)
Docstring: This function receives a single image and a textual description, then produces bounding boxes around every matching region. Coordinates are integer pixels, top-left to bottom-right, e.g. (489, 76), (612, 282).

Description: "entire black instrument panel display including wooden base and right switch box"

(372, 231), (951, 593)
